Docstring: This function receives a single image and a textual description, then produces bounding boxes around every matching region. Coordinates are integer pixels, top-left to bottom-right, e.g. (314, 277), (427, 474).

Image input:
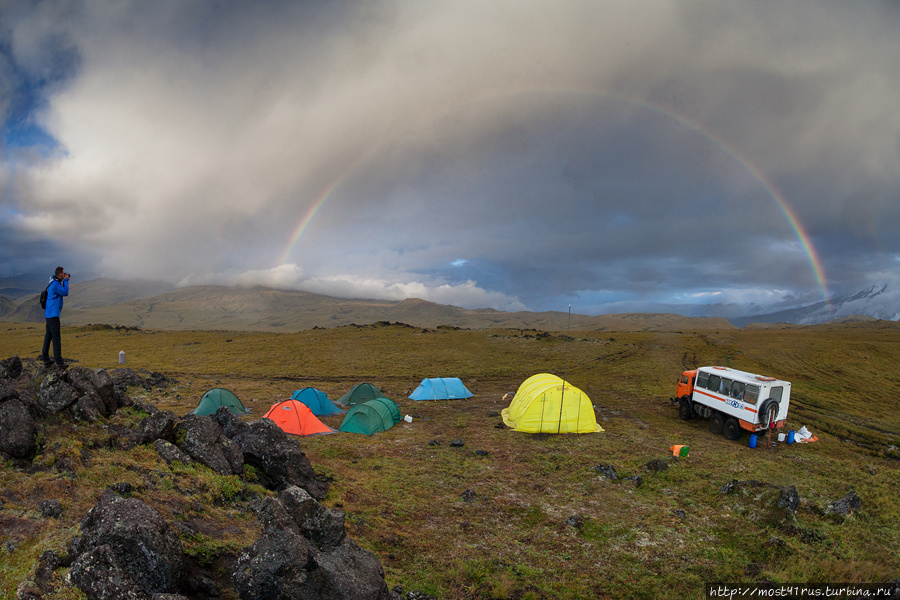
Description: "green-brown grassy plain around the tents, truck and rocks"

(0, 322), (900, 600)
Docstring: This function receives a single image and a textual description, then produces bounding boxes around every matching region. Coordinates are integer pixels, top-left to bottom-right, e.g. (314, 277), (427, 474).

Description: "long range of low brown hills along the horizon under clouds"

(0, 279), (733, 332)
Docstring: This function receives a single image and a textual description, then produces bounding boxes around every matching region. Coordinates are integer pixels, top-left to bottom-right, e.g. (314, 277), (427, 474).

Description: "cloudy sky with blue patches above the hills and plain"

(0, 0), (900, 316)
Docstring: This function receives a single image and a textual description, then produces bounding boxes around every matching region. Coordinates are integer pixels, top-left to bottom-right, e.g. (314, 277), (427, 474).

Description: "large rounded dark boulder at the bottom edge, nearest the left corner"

(70, 490), (184, 600)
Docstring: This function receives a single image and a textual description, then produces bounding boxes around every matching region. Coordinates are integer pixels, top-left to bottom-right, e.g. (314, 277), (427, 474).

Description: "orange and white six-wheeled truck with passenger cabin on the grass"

(673, 367), (791, 440)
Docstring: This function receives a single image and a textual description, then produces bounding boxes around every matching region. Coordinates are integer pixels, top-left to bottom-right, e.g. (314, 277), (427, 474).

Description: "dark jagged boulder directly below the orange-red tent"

(232, 419), (328, 500)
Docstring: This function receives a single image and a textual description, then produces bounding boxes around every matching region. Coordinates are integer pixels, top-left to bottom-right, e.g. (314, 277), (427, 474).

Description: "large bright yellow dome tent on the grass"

(500, 373), (603, 433)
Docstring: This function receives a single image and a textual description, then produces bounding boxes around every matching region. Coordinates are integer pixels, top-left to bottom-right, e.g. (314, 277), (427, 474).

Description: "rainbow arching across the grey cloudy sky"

(278, 88), (831, 308)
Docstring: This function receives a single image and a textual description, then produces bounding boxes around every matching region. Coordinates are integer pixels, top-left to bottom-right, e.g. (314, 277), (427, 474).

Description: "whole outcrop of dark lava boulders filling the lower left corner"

(0, 360), (422, 600)
